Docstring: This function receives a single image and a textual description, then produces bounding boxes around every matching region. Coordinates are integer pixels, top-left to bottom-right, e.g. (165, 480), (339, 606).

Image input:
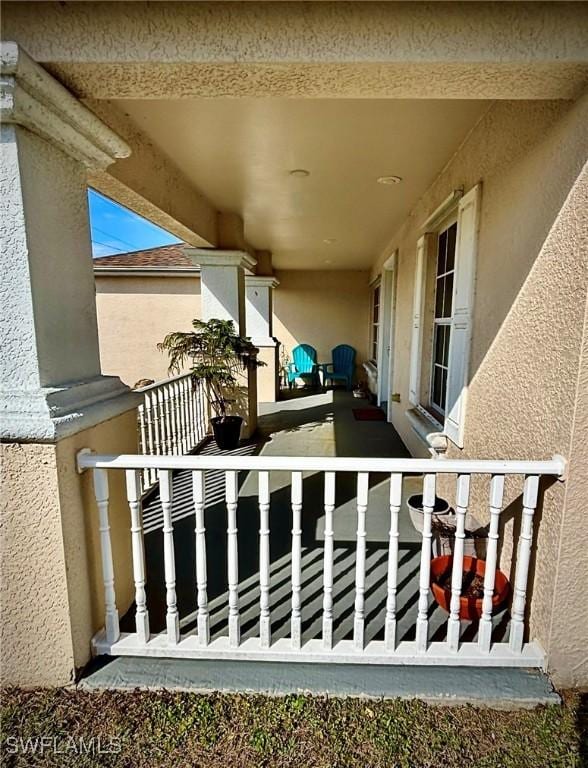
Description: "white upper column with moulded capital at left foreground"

(0, 43), (133, 441)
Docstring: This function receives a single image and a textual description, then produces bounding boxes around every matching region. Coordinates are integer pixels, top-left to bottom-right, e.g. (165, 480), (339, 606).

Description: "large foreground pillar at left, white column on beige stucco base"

(0, 43), (136, 685)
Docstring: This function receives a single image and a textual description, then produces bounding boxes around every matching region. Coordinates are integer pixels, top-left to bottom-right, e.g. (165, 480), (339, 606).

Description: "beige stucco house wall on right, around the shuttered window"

(374, 97), (588, 683)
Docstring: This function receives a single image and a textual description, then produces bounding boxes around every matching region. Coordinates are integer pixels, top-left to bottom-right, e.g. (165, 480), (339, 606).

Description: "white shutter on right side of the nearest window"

(443, 184), (482, 448)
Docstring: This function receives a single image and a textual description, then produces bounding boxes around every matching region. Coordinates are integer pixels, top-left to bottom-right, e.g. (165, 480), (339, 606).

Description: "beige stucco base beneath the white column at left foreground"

(0, 410), (137, 686)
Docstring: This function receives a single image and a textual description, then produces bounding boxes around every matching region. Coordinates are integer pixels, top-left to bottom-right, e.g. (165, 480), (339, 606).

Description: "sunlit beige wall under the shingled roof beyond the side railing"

(96, 275), (200, 387)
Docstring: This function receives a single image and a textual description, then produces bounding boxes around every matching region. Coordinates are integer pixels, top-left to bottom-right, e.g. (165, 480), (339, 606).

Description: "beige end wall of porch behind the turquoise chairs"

(273, 270), (370, 380)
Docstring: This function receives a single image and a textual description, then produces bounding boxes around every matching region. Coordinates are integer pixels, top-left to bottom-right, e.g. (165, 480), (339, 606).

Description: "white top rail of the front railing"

(78, 449), (565, 477)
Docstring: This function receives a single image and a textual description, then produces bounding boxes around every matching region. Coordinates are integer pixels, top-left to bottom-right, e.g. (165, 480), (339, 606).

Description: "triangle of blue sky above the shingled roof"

(88, 189), (181, 258)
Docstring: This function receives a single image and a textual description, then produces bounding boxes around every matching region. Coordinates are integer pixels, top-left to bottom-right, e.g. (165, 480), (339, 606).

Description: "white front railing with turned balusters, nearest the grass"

(78, 451), (565, 666)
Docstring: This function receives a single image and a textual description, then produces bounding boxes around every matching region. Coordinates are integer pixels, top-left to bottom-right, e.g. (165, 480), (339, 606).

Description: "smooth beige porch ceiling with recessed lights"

(116, 98), (488, 269)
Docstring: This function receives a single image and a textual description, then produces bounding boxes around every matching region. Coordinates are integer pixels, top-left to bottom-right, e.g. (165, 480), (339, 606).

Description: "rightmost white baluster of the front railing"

(509, 475), (539, 653)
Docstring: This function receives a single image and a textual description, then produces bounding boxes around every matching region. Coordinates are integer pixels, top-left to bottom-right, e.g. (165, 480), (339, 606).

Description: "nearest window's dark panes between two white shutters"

(428, 221), (457, 418)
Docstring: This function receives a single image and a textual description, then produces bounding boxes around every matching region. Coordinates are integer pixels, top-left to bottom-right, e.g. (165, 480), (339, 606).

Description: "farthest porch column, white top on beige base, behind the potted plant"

(245, 275), (280, 403)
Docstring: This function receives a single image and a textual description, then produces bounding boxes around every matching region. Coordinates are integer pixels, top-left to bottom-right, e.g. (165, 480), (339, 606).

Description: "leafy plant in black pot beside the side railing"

(157, 319), (263, 450)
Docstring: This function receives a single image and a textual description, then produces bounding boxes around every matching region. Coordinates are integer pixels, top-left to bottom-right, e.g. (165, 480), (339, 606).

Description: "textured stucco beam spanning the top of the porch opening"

(3, 2), (588, 99)
